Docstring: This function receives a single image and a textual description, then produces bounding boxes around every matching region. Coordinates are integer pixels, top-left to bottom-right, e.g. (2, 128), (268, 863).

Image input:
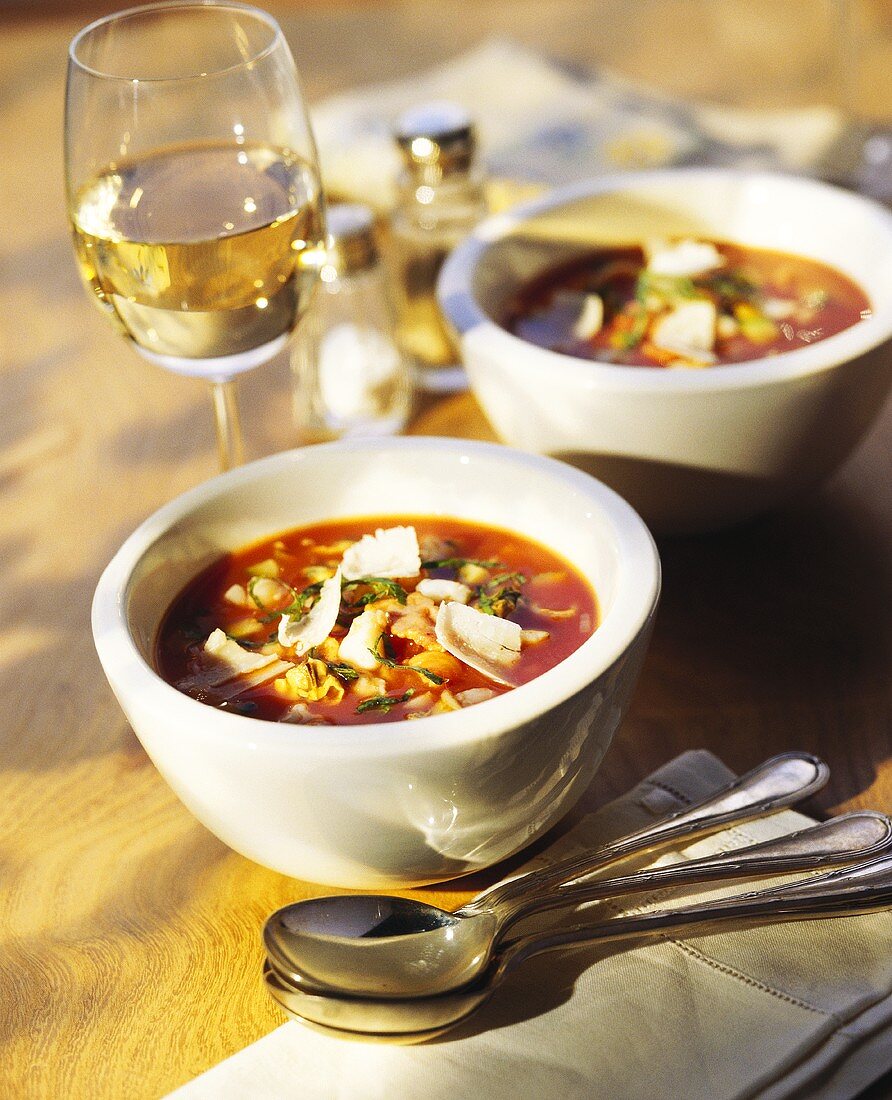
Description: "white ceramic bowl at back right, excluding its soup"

(438, 168), (892, 532)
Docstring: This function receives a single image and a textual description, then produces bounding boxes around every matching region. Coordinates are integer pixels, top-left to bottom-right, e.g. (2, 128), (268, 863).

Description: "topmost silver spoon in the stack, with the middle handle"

(265, 811), (892, 999)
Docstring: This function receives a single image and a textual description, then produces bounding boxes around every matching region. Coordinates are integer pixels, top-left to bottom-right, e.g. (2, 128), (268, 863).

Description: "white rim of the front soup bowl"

(91, 437), (661, 757)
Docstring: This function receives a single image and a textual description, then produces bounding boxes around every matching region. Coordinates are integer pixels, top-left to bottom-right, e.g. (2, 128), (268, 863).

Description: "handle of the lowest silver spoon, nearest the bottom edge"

(493, 855), (892, 980)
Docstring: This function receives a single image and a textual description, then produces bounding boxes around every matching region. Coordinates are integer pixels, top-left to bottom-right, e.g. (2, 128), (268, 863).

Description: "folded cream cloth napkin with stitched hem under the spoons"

(172, 751), (892, 1100)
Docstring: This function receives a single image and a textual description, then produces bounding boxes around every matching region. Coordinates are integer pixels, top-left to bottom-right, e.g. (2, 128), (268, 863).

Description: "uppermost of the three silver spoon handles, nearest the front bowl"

(468, 752), (829, 916)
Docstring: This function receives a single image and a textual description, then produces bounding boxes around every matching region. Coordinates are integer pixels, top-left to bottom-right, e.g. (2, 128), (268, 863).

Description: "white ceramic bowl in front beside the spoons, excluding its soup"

(92, 439), (660, 889)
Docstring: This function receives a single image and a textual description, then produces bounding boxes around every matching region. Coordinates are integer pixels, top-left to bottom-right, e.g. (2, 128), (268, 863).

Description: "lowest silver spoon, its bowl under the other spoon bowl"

(264, 855), (892, 1042)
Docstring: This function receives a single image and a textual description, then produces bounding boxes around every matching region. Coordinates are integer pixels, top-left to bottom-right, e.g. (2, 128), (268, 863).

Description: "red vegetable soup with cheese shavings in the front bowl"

(156, 517), (598, 725)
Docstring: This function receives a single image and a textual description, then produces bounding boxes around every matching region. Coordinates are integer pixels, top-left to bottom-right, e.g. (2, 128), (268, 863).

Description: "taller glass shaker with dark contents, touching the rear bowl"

(390, 102), (486, 392)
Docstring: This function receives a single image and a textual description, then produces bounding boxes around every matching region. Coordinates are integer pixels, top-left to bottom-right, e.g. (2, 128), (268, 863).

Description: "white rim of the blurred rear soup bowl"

(437, 166), (892, 394)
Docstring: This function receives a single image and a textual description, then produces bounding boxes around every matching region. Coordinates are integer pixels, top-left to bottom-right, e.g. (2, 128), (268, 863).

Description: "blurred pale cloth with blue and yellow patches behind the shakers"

(310, 39), (846, 210)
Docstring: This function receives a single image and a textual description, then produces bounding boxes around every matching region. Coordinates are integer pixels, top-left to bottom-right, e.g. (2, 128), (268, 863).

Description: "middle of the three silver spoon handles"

(499, 810), (892, 933)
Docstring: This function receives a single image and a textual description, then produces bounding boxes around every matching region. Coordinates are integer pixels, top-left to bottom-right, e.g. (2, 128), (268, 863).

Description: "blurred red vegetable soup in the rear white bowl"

(504, 240), (870, 370)
